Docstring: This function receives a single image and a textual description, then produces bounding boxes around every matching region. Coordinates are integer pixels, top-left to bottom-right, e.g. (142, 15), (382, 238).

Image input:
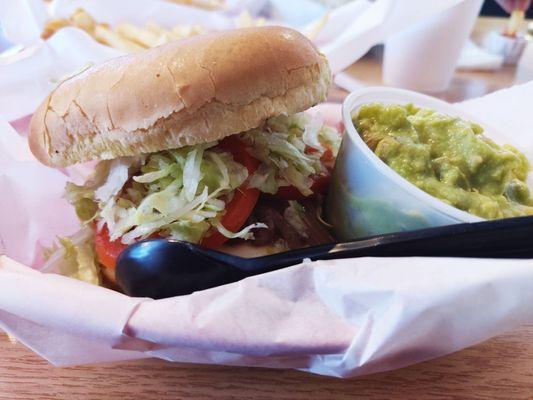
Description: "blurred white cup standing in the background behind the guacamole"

(383, 0), (483, 93)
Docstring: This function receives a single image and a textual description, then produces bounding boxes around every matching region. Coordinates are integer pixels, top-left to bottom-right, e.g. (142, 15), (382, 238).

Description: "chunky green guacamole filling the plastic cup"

(353, 103), (533, 219)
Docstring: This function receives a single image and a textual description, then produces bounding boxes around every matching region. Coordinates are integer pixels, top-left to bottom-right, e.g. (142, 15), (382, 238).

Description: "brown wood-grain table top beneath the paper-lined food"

(0, 20), (533, 400)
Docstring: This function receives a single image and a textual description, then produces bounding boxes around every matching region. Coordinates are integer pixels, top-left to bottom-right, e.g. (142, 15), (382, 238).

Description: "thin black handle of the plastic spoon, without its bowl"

(242, 216), (533, 272)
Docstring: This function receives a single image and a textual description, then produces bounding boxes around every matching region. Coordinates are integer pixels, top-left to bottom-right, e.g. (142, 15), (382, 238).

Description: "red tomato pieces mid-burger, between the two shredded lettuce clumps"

(201, 136), (260, 249)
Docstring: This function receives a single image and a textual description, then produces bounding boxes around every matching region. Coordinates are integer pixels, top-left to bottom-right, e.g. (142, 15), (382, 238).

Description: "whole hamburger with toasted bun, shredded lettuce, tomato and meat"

(29, 27), (340, 282)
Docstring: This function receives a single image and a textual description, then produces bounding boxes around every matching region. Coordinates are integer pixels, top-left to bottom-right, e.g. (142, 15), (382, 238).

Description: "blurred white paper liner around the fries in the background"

(0, 0), (470, 121)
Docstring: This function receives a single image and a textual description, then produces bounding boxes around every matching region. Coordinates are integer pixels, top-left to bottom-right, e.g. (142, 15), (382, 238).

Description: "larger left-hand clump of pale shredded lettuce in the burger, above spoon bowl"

(67, 143), (259, 244)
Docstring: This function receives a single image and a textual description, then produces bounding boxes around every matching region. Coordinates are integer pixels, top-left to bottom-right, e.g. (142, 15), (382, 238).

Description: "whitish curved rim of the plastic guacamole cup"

(342, 86), (491, 222)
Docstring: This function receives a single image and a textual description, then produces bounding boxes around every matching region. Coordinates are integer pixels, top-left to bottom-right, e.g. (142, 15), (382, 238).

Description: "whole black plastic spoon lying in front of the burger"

(116, 216), (533, 299)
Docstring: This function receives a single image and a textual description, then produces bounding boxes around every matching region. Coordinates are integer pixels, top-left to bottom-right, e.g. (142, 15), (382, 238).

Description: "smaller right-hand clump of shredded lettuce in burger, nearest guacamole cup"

(241, 113), (340, 196)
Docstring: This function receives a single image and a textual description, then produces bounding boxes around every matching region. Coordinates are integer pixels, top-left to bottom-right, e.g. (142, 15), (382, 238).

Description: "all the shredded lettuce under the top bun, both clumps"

(66, 113), (340, 250)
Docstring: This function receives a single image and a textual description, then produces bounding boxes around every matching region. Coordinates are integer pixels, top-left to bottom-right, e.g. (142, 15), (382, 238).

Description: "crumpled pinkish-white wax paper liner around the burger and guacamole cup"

(0, 80), (533, 377)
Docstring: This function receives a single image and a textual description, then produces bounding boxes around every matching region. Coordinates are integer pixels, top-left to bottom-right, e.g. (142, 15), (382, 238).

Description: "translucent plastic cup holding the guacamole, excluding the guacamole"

(326, 87), (482, 240)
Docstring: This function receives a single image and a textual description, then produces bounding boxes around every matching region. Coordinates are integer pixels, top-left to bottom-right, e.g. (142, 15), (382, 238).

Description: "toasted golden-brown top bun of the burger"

(29, 27), (331, 166)
